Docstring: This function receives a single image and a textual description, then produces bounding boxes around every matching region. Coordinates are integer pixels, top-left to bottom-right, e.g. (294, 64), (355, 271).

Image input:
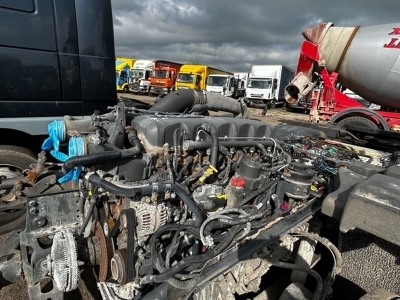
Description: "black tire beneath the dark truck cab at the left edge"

(0, 146), (37, 234)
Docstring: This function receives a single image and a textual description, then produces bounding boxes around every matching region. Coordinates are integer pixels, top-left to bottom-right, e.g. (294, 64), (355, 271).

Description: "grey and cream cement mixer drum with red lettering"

(303, 22), (400, 109)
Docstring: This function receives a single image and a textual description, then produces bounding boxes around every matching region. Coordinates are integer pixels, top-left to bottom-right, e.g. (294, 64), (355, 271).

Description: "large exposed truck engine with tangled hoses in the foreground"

(0, 91), (400, 299)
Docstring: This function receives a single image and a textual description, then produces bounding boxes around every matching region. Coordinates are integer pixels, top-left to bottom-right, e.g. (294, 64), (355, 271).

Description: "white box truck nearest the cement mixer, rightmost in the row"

(246, 65), (294, 115)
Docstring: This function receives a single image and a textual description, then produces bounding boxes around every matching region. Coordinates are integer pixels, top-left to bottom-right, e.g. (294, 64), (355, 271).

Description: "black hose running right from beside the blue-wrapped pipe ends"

(62, 147), (140, 173)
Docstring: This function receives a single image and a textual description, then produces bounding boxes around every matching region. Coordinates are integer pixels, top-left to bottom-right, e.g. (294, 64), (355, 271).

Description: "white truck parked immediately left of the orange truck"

(129, 59), (154, 94)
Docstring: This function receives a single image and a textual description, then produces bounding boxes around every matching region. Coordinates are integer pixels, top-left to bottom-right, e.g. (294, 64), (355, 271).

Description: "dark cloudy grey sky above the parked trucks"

(111, 0), (400, 72)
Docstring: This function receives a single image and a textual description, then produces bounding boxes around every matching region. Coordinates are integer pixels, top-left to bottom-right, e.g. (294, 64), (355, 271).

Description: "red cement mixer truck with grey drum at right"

(285, 23), (400, 150)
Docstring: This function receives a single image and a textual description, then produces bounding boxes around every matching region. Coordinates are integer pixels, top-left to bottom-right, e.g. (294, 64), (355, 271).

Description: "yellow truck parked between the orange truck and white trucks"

(175, 64), (230, 90)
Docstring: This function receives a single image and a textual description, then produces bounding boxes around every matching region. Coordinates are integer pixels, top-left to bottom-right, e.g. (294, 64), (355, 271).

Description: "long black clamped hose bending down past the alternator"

(87, 174), (203, 227)
